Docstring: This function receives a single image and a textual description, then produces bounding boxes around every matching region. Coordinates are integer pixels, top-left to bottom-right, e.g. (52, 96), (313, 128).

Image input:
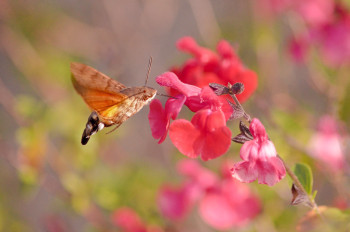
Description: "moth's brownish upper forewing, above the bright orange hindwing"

(70, 63), (126, 94)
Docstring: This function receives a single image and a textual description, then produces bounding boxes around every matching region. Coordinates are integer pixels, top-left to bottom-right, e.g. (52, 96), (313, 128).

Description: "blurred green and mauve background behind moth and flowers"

(0, 0), (350, 232)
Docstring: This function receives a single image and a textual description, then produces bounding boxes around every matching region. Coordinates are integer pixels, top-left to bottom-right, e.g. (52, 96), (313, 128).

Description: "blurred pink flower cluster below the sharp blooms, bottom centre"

(158, 160), (260, 230)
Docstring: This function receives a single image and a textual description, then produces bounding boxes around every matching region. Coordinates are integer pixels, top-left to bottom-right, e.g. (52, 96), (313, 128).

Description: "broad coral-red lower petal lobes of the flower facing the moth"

(169, 109), (231, 161)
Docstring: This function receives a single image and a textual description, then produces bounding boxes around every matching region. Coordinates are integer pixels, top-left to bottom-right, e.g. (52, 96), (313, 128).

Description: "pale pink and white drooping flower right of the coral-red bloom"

(231, 118), (286, 186)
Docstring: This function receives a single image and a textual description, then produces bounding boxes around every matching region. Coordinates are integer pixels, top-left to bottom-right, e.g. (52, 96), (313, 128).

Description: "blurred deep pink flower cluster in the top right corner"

(260, 0), (350, 67)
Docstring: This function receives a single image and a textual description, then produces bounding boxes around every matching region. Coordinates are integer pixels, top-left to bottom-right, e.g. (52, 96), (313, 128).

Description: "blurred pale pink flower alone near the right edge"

(310, 115), (345, 171)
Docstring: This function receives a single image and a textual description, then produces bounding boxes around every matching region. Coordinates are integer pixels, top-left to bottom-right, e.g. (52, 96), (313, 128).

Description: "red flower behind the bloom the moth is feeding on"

(171, 37), (257, 101)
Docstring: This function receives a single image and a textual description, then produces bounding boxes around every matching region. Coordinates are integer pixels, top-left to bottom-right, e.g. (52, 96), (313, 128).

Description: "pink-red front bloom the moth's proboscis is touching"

(148, 72), (233, 160)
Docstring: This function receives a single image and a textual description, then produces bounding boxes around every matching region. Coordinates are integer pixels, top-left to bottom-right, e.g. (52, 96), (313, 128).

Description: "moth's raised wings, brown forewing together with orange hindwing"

(71, 63), (128, 121)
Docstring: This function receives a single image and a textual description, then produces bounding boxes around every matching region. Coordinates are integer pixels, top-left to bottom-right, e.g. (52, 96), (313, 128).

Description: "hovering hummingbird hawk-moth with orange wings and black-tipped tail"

(70, 63), (157, 145)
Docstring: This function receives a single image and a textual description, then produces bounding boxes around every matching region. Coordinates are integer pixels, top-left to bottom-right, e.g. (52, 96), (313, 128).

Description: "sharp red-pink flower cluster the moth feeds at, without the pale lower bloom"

(149, 37), (257, 160)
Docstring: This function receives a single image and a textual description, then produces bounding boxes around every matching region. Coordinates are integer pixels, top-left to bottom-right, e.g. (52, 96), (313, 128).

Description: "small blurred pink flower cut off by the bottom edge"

(111, 207), (163, 232)
